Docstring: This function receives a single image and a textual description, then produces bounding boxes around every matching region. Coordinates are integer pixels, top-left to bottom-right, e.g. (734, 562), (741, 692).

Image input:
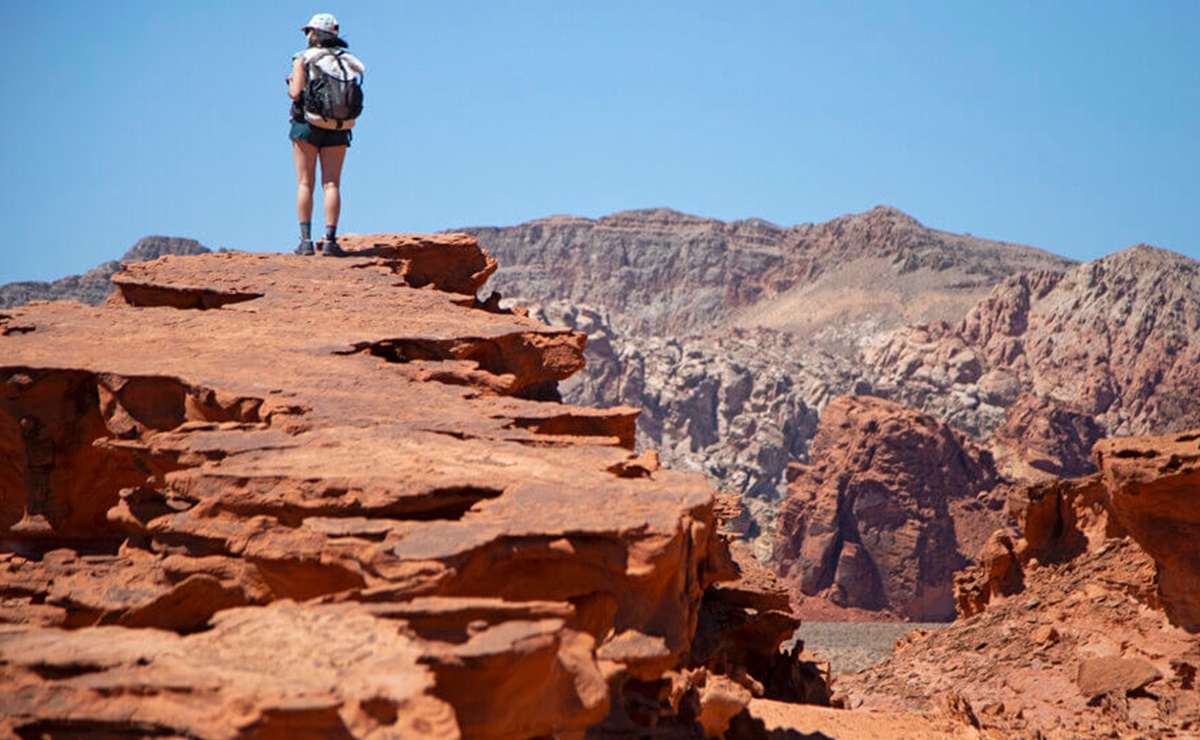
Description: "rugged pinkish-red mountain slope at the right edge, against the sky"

(864, 245), (1200, 479)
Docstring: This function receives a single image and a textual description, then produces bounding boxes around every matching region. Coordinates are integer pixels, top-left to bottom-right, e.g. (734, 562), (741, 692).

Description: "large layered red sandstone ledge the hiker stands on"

(0, 235), (827, 738)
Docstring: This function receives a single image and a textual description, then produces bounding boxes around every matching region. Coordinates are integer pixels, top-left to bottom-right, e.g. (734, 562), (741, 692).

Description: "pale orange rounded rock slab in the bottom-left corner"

(0, 602), (460, 738)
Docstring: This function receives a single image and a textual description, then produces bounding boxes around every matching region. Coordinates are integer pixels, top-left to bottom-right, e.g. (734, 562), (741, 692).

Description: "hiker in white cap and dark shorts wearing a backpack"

(288, 13), (365, 257)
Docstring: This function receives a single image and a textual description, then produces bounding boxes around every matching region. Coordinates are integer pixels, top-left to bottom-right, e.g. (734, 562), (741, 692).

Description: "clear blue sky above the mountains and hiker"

(0, 0), (1200, 283)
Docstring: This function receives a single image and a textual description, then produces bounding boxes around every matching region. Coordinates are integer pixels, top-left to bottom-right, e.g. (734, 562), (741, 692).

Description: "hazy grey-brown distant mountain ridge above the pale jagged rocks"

(462, 201), (1074, 353)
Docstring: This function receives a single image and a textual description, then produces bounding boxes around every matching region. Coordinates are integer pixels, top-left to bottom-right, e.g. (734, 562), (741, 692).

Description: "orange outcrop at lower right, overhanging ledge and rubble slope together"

(841, 432), (1200, 738)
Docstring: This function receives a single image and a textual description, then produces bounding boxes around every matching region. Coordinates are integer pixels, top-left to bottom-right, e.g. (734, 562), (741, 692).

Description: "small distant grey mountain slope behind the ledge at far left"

(0, 236), (211, 308)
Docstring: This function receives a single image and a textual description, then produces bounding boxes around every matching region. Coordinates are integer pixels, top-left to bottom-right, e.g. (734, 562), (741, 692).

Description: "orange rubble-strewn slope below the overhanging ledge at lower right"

(839, 537), (1200, 740)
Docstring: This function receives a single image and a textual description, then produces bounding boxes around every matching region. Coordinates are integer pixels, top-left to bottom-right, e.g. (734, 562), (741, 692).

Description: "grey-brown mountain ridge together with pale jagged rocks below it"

(472, 207), (1072, 566)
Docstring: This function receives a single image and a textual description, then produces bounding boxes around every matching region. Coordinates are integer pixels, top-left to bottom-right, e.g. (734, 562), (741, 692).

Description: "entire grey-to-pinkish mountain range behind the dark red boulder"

(463, 207), (1200, 618)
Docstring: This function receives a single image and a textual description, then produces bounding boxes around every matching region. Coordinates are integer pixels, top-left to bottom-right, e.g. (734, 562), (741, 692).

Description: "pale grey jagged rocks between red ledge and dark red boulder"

(530, 302), (853, 549)
